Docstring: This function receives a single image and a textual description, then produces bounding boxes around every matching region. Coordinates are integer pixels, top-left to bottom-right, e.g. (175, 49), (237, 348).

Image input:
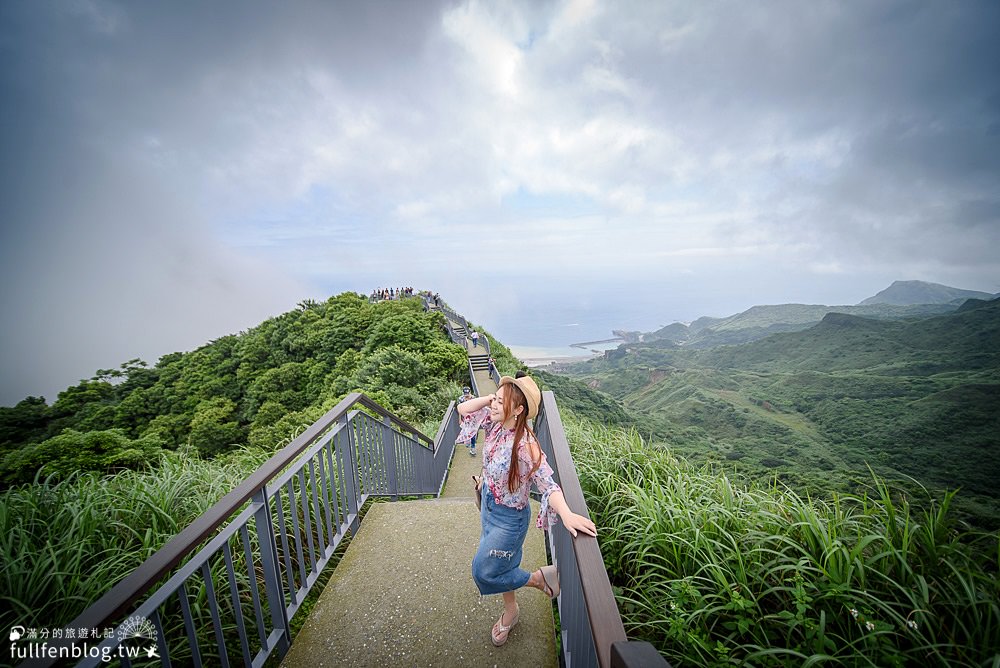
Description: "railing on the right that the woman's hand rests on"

(535, 391), (669, 668)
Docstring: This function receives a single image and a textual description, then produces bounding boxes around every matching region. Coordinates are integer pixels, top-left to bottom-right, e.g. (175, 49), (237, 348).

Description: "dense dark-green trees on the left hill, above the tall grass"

(0, 293), (467, 485)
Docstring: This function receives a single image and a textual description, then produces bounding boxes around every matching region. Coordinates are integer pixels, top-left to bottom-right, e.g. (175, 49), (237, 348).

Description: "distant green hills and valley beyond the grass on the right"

(567, 300), (1000, 526)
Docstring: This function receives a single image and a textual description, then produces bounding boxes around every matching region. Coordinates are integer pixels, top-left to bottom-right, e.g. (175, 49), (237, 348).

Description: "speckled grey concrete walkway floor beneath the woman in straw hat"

(281, 314), (558, 668)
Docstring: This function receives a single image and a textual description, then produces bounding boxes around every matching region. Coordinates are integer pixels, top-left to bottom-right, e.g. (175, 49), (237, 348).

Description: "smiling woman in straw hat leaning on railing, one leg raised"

(457, 372), (597, 647)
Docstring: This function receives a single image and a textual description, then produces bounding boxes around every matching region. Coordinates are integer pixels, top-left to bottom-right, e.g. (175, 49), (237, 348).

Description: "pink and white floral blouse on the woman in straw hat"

(455, 406), (562, 529)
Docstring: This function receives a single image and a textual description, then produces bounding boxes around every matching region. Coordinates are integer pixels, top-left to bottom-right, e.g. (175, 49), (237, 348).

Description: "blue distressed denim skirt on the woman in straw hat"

(472, 489), (531, 596)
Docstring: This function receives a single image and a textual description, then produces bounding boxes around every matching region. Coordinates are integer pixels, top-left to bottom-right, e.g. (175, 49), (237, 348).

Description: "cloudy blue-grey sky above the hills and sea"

(0, 0), (1000, 405)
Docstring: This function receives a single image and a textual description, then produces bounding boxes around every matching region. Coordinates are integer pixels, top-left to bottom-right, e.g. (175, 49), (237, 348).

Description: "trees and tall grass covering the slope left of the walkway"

(0, 293), (467, 646)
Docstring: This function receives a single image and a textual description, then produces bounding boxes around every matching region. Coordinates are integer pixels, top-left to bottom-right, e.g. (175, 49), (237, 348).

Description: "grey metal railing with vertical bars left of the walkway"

(31, 393), (458, 666)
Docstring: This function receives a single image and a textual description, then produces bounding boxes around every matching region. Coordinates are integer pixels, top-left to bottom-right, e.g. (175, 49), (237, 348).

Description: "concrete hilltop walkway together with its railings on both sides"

(35, 298), (668, 668)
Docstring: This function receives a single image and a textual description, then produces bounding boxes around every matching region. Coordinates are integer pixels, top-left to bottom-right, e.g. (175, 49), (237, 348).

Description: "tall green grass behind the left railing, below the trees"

(0, 425), (412, 666)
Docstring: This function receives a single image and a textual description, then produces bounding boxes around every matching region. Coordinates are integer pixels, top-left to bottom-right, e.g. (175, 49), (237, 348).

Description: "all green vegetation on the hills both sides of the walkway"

(0, 294), (1000, 666)
